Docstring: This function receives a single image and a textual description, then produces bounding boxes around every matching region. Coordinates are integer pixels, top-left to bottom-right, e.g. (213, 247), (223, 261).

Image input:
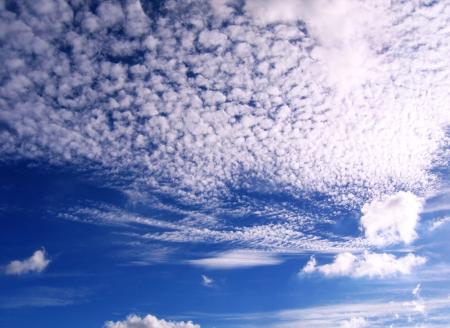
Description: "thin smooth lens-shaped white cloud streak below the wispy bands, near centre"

(189, 249), (282, 269)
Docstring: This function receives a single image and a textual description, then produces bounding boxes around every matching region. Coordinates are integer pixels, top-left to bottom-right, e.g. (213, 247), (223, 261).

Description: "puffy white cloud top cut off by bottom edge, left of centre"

(104, 314), (200, 328)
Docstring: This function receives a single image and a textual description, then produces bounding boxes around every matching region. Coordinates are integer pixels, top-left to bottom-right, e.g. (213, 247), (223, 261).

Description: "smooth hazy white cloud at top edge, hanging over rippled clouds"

(245, 0), (390, 92)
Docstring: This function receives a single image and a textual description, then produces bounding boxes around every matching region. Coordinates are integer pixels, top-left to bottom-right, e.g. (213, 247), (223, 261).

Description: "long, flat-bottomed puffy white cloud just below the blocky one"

(301, 252), (426, 278)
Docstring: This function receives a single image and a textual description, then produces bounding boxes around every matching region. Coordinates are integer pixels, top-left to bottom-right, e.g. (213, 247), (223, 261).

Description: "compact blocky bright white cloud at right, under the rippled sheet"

(361, 191), (423, 246)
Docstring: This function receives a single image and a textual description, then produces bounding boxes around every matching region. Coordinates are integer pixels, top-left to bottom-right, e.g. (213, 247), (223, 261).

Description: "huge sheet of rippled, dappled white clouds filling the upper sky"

(0, 0), (450, 204)
